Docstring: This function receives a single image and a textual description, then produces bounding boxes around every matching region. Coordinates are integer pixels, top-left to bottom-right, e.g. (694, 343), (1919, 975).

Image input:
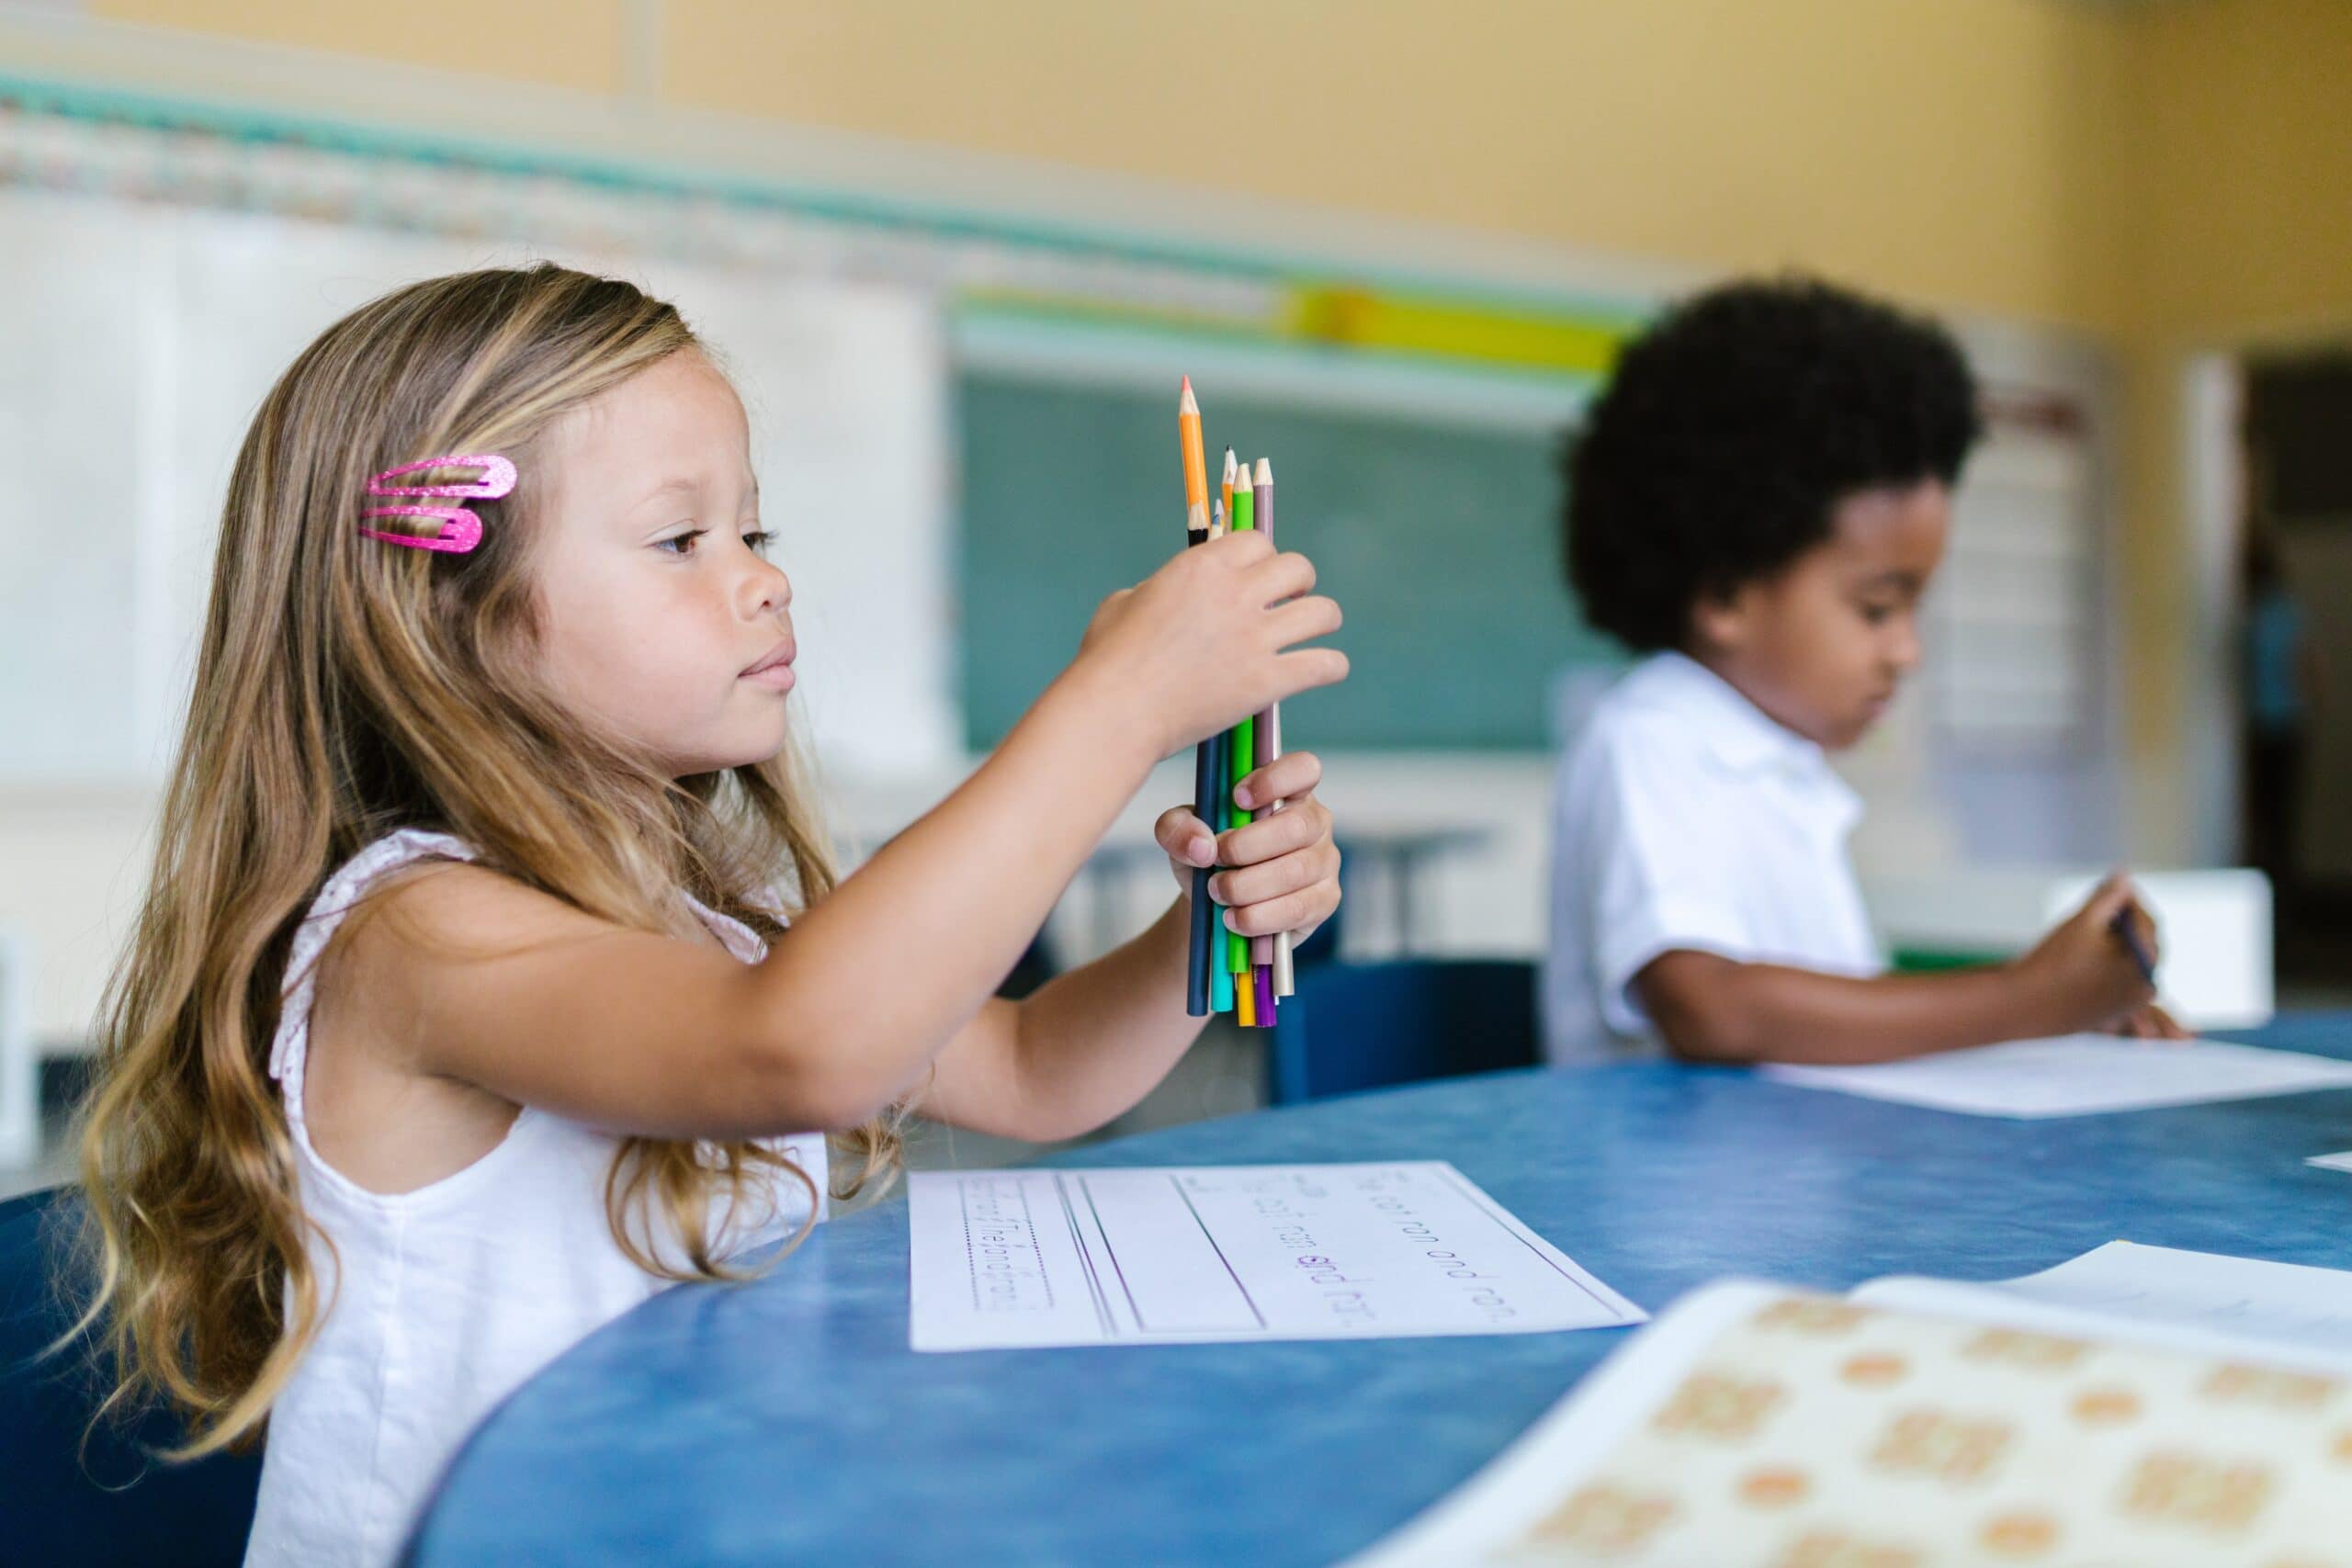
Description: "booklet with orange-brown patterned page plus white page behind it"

(1348, 1241), (2352, 1568)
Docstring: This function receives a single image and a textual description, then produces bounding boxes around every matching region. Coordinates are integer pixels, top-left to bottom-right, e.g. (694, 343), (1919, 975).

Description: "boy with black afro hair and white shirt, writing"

(1543, 280), (2180, 1063)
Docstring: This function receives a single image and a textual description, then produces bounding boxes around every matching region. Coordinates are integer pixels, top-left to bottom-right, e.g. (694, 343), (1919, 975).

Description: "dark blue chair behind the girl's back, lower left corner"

(0, 1187), (261, 1568)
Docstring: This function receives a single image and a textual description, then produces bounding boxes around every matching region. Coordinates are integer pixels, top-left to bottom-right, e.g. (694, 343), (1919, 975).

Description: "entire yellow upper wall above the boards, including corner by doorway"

(18, 0), (2352, 884)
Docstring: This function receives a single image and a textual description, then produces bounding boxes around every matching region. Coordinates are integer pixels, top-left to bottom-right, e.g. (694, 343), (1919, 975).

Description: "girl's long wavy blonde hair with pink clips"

(83, 265), (896, 1458)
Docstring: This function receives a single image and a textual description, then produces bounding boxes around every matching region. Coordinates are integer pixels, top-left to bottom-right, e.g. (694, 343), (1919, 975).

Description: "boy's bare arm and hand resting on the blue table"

(1633, 877), (2183, 1063)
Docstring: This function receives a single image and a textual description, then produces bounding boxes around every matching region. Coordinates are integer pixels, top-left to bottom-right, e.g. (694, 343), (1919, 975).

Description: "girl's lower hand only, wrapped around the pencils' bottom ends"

(1152, 747), (1339, 942)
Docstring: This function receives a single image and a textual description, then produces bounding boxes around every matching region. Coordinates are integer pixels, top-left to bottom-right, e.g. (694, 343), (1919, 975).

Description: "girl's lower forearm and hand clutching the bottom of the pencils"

(917, 752), (1339, 1143)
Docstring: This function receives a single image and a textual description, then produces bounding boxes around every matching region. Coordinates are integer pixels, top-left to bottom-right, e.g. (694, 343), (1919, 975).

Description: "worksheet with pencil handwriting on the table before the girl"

(908, 1159), (1646, 1349)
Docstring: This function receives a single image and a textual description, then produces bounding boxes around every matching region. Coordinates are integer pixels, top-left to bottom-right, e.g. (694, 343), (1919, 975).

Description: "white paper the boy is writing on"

(1761, 1034), (2352, 1119)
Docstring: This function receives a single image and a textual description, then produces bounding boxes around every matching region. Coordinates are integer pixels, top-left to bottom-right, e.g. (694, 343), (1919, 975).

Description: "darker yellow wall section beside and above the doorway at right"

(2117, 0), (2352, 861)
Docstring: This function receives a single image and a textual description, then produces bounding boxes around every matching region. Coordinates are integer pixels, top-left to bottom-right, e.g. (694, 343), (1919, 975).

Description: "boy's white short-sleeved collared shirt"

(1543, 653), (1882, 1063)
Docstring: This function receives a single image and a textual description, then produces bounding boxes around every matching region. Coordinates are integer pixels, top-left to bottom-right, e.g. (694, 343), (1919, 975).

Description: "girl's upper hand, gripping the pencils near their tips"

(1066, 534), (1348, 757)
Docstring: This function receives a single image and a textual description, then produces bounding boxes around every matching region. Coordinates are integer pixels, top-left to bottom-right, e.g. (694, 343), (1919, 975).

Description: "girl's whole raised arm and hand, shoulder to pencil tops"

(336, 534), (1348, 1138)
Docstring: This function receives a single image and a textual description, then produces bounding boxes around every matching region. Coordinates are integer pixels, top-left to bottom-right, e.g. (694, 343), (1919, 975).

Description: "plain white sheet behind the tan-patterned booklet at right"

(1853, 1241), (2352, 1373)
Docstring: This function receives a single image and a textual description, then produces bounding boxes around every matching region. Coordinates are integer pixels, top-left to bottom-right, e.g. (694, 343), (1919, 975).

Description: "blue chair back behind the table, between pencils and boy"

(1268, 959), (1541, 1105)
